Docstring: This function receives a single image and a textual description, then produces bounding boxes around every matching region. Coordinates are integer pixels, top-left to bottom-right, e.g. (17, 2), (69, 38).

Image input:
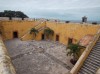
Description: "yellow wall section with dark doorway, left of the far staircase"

(0, 21), (37, 40)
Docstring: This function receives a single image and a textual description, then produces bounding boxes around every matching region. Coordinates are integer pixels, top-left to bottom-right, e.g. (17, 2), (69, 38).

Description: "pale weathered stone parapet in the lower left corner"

(0, 36), (16, 74)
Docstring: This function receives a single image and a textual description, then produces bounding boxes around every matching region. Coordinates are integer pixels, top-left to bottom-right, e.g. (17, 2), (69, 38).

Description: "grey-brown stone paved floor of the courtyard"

(5, 39), (73, 74)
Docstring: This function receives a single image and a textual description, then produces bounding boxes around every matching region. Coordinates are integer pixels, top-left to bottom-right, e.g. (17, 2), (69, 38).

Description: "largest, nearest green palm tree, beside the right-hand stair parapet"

(67, 43), (85, 64)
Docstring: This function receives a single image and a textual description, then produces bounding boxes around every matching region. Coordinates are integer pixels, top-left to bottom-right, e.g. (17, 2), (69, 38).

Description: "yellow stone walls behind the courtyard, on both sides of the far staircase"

(0, 21), (100, 44)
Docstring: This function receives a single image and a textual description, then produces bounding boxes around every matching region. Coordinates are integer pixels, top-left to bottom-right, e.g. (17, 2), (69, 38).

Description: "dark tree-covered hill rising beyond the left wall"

(0, 10), (28, 20)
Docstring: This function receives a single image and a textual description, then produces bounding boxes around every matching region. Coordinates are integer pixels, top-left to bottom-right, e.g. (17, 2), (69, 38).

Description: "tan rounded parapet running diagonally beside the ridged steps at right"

(70, 29), (100, 74)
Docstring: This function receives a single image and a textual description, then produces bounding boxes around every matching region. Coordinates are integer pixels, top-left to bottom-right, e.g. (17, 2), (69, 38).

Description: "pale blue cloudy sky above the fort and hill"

(0, 0), (100, 21)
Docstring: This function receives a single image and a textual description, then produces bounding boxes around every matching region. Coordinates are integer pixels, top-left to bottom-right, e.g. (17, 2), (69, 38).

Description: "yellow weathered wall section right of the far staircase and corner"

(47, 22), (100, 44)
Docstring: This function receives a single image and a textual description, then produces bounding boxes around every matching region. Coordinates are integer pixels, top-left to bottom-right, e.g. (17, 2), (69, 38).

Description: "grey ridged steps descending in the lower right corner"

(78, 35), (100, 74)
